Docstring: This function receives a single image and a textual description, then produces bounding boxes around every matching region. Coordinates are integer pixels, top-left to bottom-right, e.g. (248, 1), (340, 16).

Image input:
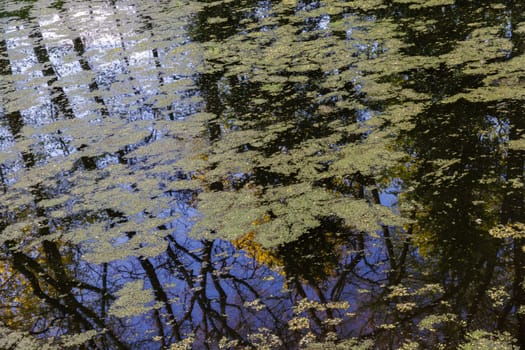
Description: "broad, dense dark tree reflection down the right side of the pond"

(362, 1), (524, 348)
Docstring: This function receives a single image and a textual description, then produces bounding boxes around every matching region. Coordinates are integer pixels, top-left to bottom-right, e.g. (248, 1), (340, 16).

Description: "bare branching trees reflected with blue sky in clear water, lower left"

(2, 219), (370, 348)
